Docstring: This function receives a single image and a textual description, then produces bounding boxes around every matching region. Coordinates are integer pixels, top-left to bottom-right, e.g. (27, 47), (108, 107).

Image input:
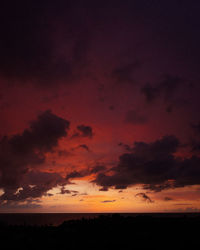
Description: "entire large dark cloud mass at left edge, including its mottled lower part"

(0, 110), (69, 200)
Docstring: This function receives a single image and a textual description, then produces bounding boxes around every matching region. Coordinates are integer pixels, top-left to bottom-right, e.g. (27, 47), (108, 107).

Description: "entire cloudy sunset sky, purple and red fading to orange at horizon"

(0, 0), (200, 213)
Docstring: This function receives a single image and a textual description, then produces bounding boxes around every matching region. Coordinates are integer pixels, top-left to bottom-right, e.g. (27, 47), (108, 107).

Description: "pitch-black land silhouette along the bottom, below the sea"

(0, 214), (200, 250)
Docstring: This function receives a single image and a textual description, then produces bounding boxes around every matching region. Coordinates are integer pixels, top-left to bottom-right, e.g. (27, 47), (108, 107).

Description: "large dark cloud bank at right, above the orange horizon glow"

(93, 136), (200, 192)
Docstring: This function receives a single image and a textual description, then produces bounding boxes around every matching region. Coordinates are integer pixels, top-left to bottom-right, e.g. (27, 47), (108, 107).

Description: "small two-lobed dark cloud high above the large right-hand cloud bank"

(141, 75), (183, 103)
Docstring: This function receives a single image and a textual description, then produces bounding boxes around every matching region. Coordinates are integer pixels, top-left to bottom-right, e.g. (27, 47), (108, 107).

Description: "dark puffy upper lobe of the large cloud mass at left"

(9, 110), (70, 154)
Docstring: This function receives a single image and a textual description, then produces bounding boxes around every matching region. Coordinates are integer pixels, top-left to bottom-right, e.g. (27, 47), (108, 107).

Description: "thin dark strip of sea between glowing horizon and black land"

(0, 213), (200, 226)
